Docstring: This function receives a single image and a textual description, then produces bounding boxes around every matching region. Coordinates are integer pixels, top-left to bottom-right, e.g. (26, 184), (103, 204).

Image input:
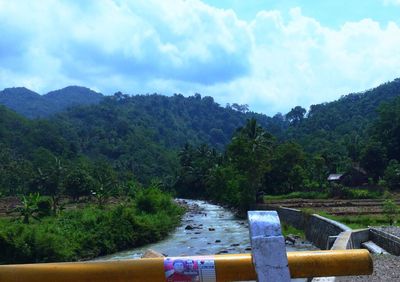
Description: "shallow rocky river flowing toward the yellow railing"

(98, 200), (315, 281)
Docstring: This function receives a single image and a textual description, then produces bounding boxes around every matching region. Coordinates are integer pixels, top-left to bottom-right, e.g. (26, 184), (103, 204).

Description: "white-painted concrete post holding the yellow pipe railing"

(247, 211), (290, 282)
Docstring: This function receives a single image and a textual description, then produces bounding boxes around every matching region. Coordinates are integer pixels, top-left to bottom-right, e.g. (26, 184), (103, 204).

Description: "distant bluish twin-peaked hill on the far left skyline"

(0, 86), (104, 118)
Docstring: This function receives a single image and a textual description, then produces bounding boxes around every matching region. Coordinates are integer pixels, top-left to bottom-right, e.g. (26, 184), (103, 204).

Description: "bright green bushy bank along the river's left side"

(0, 188), (184, 264)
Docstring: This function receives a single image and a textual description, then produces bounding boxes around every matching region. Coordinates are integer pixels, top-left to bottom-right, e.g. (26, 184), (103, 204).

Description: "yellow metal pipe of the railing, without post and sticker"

(0, 250), (373, 282)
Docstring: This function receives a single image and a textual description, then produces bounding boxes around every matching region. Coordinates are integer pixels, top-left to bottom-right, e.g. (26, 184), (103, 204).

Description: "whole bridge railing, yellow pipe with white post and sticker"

(0, 211), (373, 282)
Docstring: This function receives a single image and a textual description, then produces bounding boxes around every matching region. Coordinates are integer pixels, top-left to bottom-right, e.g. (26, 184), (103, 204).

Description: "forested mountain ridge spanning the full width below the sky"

(0, 77), (400, 189)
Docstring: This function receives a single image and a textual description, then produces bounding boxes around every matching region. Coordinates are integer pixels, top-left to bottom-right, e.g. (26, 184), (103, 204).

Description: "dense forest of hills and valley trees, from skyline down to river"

(0, 79), (400, 237)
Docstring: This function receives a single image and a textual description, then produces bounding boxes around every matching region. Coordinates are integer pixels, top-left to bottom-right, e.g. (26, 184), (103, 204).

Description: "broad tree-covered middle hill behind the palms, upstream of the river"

(53, 93), (282, 182)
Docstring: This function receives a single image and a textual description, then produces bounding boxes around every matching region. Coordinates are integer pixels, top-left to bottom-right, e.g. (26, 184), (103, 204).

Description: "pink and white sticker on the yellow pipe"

(164, 257), (216, 282)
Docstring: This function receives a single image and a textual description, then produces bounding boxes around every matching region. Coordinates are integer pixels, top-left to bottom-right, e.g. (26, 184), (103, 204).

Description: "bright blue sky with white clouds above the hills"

(0, 0), (400, 115)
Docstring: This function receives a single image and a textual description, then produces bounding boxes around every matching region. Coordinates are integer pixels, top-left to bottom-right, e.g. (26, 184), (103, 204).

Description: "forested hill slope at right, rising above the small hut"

(283, 79), (400, 171)
